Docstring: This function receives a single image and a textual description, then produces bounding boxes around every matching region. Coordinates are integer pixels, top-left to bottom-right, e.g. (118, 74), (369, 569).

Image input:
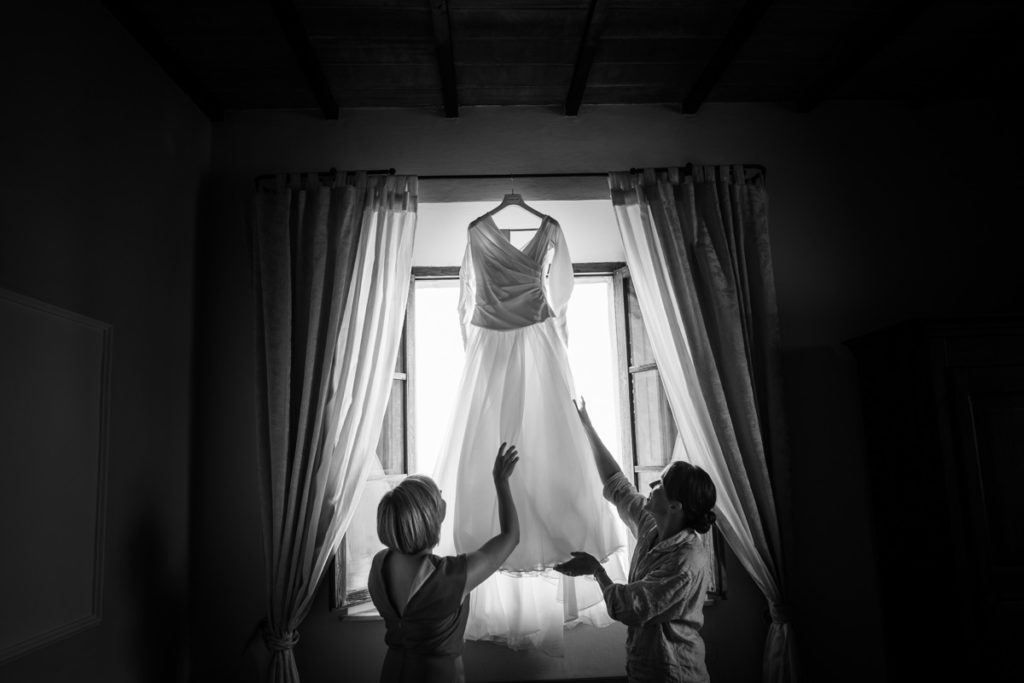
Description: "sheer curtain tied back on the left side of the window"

(250, 173), (417, 682)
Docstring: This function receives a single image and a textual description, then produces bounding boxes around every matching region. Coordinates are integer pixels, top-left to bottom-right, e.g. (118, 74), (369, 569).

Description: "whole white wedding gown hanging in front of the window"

(435, 210), (626, 654)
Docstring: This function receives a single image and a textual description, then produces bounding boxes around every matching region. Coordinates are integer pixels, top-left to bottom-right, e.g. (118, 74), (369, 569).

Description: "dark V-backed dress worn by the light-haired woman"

(368, 550), (469, 683)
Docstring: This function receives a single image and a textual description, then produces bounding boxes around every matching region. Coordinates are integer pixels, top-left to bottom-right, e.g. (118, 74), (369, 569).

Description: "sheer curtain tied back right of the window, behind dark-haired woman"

(609, 166), (797, 683)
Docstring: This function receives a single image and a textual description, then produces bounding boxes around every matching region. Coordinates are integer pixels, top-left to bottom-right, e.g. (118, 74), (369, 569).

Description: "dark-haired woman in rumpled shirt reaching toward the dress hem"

(555, 399), (716, 683)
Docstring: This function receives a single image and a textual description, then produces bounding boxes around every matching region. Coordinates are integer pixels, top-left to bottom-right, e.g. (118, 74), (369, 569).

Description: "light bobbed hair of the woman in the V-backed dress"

(377, 474), (444, 555)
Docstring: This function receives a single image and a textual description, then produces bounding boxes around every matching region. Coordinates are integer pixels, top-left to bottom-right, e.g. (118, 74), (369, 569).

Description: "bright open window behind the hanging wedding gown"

(329, 263), (725, 617)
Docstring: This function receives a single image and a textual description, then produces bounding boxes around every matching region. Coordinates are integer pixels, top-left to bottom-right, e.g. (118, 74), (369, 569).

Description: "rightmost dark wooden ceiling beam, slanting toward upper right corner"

(797, 0), (935, 113)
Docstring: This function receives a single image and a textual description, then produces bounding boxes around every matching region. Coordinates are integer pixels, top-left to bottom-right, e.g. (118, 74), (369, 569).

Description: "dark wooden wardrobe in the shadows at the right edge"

(848, 317), (1024, 682)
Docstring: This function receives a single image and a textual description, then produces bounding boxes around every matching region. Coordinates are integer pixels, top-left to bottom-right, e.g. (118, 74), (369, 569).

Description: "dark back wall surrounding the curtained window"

(194, 102), (1021, 683)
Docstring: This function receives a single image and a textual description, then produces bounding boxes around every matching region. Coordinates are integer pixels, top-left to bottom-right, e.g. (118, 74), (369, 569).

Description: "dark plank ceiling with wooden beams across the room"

(104, 0), (1024, 119)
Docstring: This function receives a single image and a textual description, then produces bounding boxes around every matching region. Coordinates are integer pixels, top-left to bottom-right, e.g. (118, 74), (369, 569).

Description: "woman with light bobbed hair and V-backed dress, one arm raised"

(369, 443), (519, 683)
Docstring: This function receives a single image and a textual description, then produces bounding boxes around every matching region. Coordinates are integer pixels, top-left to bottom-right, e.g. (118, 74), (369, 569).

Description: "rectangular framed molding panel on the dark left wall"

(0, 288), (113, 664)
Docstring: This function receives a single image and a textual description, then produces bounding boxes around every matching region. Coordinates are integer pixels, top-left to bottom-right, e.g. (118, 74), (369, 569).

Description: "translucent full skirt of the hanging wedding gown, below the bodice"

(434, 318), (626, 654)
